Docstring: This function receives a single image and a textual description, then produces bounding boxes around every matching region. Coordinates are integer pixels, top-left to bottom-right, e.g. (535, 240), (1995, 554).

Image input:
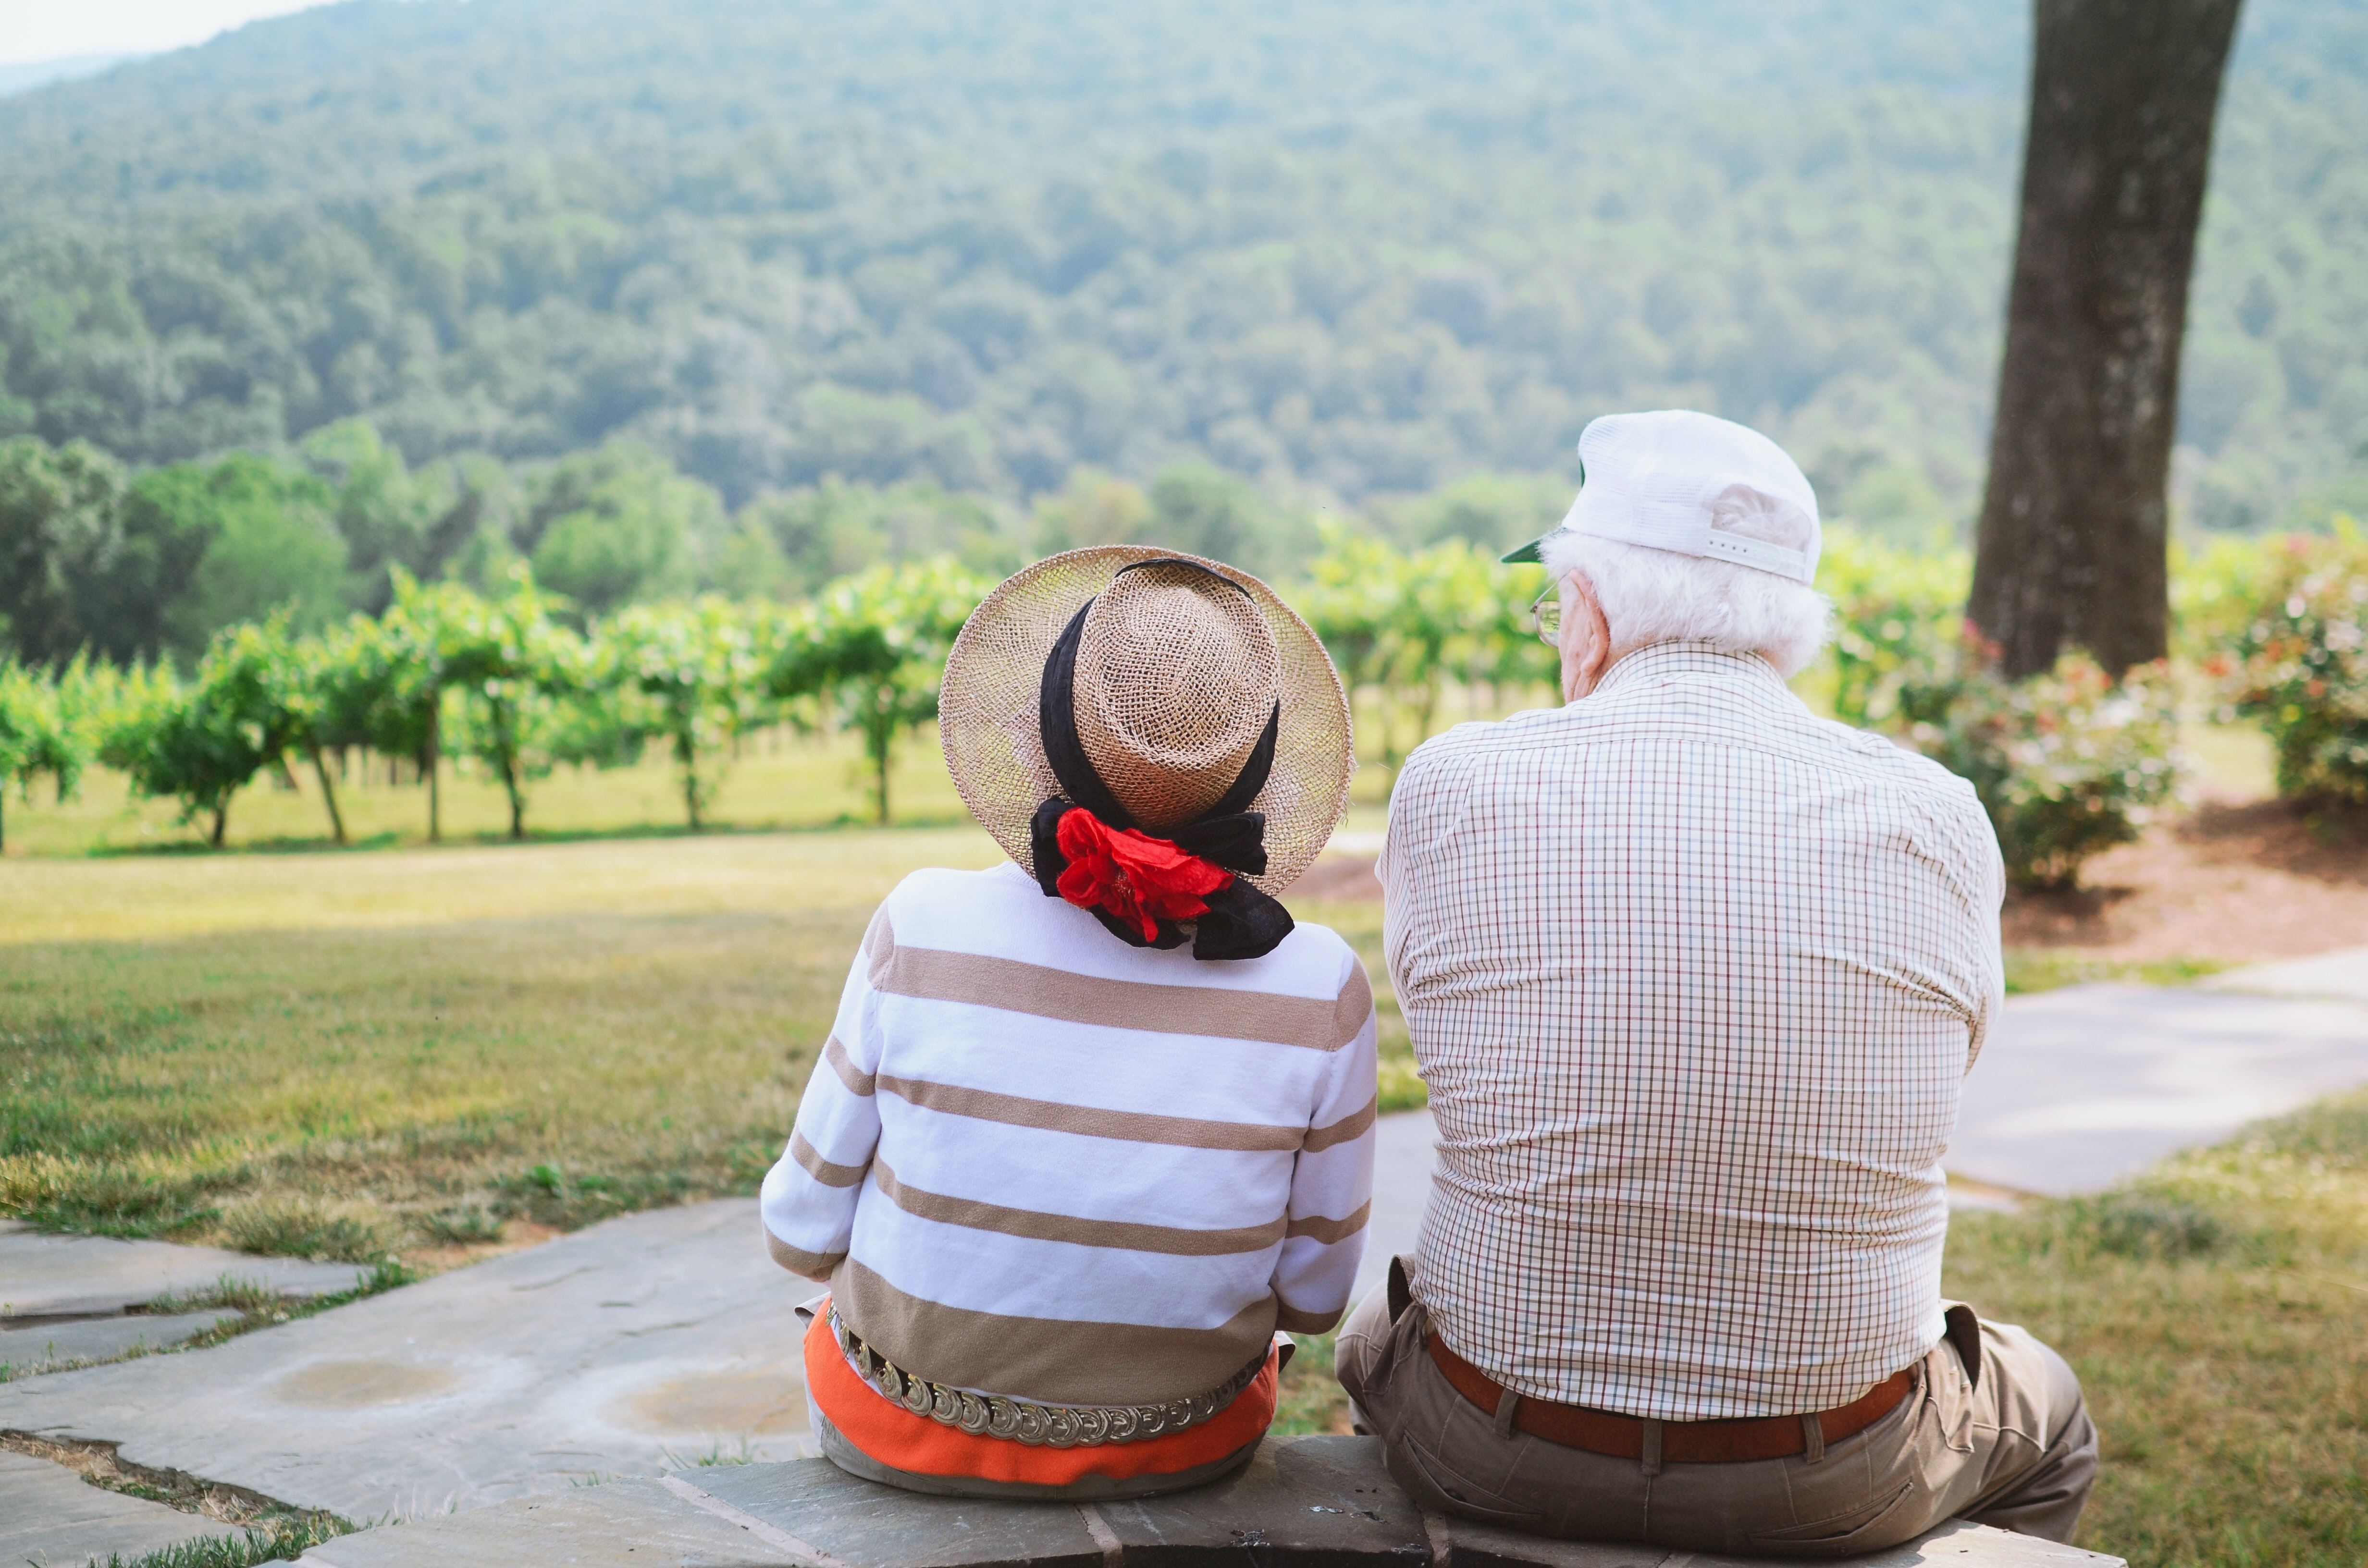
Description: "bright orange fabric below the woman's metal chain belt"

(805, 1310), (1276, 1487)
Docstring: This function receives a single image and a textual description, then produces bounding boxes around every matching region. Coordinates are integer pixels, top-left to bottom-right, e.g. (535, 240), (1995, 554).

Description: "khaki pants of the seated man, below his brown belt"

(1335, 1288), (2096, 1556)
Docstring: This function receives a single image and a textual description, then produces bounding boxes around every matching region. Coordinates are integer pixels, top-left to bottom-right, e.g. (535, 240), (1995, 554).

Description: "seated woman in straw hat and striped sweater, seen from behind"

(763, 547), (1373, 1499)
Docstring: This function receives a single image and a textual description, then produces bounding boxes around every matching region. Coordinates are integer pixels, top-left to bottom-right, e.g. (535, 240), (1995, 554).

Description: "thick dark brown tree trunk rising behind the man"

(1968, 0), (2240, 677)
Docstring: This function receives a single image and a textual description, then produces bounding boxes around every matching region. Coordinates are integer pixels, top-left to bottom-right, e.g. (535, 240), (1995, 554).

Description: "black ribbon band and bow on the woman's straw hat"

(1028, 562), (1293, 959)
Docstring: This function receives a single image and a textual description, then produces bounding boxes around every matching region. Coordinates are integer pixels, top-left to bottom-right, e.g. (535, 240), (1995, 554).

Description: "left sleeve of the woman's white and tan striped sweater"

(758, 905), (895, 1279)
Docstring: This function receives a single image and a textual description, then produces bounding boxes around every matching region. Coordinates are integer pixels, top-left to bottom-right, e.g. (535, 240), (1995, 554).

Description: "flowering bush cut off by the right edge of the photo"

(2207, 516), (2368, 803)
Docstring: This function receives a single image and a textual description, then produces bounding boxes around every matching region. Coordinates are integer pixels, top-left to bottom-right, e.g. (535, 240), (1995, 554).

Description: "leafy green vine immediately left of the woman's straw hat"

(814, 562), (995, 827)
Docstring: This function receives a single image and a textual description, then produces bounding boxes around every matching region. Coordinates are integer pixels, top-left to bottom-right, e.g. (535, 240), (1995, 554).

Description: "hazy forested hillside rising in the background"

(0, 0), (2368, 528)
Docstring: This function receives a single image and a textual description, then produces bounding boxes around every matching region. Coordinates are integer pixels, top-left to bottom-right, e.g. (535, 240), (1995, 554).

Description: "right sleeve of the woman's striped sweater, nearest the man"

(1274, 955), (1378, 1334)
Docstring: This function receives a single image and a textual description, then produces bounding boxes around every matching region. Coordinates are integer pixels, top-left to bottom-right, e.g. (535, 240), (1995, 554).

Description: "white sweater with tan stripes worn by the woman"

(763, 862), (1376, 1405)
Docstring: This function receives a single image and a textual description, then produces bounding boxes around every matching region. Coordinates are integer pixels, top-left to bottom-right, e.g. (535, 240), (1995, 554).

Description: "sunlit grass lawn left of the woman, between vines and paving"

(0, 829), (997, 1260)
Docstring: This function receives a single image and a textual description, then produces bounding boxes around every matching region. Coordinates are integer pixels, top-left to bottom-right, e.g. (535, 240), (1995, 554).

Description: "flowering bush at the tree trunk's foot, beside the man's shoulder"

(1899, 649), (2179, 888)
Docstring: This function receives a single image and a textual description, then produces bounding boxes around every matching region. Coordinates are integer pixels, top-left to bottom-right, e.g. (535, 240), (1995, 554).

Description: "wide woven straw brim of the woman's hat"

(937, 545), (1357, 893)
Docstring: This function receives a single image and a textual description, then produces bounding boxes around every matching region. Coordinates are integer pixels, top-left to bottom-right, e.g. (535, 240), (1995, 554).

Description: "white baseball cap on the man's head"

(1501, 407), (1821, 583)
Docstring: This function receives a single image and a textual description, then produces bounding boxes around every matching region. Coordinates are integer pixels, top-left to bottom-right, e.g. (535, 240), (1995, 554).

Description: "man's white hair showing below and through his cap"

(1542, 490), (1833, 677)
